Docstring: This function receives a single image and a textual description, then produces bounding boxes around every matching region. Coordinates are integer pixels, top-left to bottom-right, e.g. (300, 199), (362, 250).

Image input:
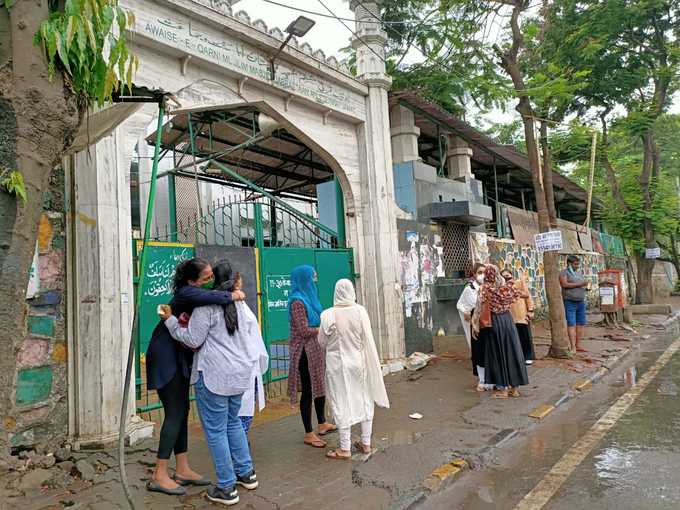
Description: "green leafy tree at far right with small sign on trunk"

(547, 0), (680, 303)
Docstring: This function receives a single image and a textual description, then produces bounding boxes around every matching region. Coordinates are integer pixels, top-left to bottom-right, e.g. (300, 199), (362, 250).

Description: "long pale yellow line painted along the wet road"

(515, 338), (680, 510)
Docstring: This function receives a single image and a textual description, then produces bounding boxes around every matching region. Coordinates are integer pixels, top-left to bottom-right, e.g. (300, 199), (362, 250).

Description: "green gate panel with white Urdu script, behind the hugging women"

(135, 241), (194, 354)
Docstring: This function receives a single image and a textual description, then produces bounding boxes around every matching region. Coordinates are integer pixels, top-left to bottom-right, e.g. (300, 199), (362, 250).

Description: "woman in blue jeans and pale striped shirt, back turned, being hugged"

(161, 262), (258, 505)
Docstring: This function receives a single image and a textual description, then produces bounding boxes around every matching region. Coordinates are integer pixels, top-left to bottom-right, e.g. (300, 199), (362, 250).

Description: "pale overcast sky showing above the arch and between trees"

(234, 0), (680, 124)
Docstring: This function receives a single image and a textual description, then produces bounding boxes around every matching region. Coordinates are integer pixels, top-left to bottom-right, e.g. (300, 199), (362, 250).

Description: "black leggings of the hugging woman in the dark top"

(157, 368), (189, 460)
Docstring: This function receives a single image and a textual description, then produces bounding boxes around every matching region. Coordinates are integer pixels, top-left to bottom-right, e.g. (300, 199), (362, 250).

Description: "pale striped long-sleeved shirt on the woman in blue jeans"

(165, 305), (257, 396)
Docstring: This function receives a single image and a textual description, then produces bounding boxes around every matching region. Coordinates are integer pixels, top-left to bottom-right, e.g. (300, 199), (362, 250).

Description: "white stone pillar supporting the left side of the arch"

(67, 117), (153, 447)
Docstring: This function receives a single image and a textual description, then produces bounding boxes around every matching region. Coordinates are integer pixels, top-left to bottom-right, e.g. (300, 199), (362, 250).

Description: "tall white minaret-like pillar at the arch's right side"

(350, 0), (405, 360)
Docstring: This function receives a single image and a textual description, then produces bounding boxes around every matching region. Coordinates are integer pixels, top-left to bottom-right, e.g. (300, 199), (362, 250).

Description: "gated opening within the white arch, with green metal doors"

(133, 103), (356, 413)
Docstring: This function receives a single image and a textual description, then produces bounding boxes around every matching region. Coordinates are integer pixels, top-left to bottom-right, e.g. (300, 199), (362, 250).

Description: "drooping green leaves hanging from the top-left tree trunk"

(35, 0), (139, 106)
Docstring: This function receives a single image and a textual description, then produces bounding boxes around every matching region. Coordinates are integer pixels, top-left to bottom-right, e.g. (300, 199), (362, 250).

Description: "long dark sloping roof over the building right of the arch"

(390, 91), (597, 223)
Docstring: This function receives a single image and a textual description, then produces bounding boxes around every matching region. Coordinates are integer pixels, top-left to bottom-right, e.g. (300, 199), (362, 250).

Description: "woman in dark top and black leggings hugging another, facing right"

(146, 258), (245, 496)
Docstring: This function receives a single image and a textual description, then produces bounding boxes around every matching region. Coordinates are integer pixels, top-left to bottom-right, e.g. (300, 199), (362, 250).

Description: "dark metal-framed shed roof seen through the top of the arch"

(147, 103), (334, 197)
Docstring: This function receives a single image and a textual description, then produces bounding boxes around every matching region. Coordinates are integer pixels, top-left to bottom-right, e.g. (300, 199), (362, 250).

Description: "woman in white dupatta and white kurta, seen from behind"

(319, 279), (390, 459)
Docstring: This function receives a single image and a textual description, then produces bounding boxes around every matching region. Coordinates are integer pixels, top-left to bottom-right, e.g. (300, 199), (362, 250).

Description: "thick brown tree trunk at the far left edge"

(0, 0), (79, 457)
